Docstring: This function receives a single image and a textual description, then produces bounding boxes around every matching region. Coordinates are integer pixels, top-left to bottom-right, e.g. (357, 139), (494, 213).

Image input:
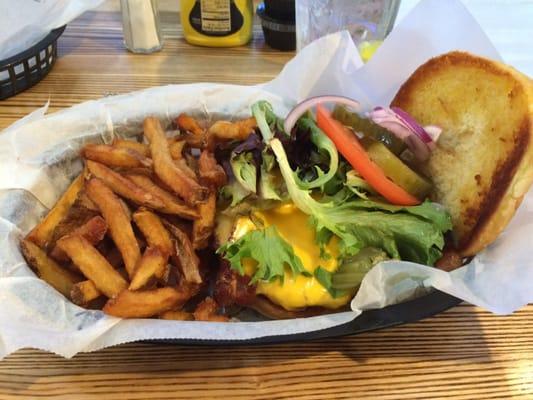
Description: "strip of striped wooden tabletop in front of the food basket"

(0, 305), (533, 399)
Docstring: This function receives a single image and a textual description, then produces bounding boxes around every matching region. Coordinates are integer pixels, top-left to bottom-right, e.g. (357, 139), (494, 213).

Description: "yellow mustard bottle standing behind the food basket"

(180, 0), (253, 47)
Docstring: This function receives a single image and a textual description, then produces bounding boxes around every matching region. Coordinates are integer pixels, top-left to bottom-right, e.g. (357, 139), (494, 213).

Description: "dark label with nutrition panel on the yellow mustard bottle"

(189, 0), (244, 36)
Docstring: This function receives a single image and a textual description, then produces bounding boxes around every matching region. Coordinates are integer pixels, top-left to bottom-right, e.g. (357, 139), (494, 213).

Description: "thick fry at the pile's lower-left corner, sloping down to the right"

(20, 239), (80, 297)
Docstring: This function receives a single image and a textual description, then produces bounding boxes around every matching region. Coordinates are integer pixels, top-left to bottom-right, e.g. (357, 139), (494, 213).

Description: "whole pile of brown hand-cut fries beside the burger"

(21, 114), (250, 321)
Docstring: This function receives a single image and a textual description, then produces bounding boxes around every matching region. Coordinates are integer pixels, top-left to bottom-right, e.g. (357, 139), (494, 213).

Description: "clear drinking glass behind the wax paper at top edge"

(296, 0), (400, 56)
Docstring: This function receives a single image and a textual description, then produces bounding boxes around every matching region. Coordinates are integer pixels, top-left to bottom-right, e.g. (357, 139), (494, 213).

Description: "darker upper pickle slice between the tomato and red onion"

(332, 106), (406, 155)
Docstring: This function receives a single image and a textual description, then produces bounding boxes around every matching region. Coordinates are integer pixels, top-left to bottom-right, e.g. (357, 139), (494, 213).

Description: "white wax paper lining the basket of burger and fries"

(0, 0), (533, 357)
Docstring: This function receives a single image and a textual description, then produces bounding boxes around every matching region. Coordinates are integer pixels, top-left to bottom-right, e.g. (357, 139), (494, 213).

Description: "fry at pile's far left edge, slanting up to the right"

(27, 174), (84, 247)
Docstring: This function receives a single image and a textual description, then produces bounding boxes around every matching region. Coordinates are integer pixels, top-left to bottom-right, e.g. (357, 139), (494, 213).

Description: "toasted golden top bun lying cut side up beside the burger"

(392, 52), (533, 257)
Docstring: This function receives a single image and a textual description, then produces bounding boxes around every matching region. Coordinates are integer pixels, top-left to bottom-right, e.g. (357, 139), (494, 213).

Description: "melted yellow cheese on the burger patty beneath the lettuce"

(232, 204), (351, 310)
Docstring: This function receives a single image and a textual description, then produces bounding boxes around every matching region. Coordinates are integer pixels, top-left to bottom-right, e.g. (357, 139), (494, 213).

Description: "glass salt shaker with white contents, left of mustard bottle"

(120, 0), (163, 53)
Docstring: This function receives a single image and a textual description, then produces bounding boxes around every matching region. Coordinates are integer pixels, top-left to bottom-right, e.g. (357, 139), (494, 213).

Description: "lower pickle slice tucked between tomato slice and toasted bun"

(361, 138), (431, 200)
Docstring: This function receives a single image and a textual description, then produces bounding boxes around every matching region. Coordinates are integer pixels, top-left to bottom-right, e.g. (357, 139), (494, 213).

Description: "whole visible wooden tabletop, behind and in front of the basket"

(0, 3), (533, 399)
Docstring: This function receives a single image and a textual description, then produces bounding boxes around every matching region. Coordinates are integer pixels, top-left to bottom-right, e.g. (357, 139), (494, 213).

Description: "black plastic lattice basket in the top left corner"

(0, 26), (65, 100)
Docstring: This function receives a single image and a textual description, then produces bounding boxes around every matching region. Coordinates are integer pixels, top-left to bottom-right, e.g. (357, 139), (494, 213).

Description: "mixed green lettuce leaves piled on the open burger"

(218, 101), (452, 297)
